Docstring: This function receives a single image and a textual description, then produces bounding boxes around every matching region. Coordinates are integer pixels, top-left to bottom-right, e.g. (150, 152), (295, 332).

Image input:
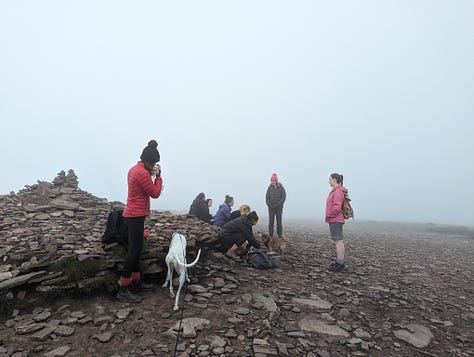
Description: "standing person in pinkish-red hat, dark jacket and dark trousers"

(265, 174), (286, 238)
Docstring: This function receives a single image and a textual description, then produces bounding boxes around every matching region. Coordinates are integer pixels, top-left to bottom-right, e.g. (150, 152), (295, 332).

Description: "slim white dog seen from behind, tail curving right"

(163, 232), (201, 311)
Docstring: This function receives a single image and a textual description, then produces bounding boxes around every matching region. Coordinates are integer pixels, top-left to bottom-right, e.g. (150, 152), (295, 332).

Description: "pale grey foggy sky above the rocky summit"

(0, 0), (474, 225)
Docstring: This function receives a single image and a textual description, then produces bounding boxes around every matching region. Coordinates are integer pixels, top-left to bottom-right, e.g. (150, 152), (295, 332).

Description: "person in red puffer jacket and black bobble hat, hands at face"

(117, 140), (163, 303)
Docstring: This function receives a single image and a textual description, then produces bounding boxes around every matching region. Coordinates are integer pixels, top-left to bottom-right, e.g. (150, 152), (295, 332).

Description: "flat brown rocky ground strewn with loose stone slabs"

(0, 220), (474, 357)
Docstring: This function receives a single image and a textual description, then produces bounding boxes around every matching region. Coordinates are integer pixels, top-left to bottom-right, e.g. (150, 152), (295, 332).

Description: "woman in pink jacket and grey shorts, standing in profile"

(325, 173), (348, 272)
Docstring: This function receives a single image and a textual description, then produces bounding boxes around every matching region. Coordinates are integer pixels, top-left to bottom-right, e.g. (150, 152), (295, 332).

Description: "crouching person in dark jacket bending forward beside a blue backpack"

(216, 211), (260, 261)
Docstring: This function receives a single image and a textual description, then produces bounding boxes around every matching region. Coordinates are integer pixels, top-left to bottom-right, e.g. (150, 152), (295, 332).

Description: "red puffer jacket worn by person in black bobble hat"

(123, 161), (163, 218)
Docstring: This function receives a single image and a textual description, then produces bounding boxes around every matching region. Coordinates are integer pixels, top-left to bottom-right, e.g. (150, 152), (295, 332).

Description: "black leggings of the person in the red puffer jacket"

(122, 216), (145, 278)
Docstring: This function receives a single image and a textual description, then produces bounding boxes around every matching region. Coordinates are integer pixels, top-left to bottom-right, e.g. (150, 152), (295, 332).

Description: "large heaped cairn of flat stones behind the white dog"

(0, 170), (217, 313)
